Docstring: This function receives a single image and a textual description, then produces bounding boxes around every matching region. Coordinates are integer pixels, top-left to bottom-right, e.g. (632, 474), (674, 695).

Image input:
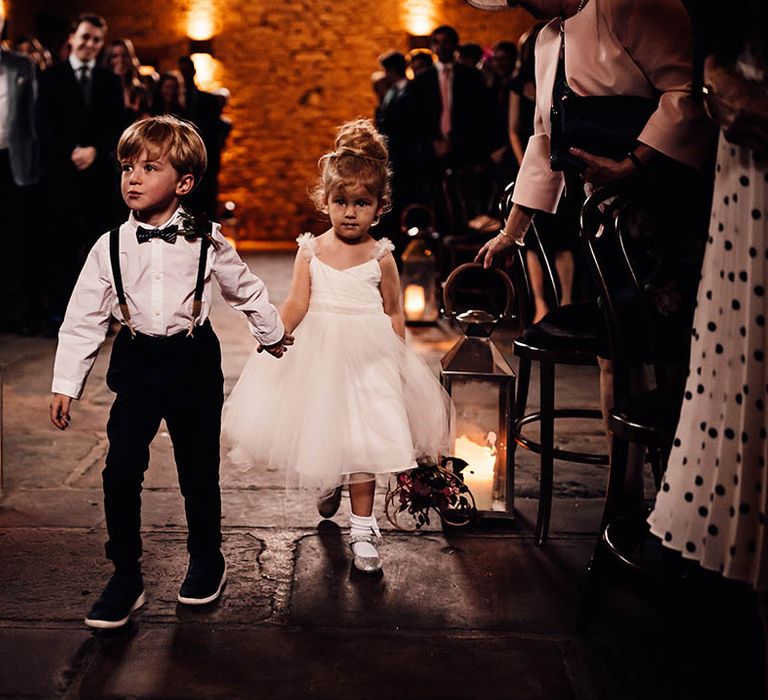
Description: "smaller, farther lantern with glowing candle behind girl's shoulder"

(400, 204), (440, 326)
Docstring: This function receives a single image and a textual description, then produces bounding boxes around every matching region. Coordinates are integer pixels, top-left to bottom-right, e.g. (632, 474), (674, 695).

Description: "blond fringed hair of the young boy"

(117, 114), (208, 187)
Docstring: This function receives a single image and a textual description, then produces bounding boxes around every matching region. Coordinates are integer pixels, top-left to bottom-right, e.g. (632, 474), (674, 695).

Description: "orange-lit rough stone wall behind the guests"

(6, 0), (531, 240)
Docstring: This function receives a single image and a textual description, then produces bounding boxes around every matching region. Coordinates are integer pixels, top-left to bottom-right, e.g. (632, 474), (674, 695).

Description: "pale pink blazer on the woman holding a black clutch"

(513, 0), (715, 213)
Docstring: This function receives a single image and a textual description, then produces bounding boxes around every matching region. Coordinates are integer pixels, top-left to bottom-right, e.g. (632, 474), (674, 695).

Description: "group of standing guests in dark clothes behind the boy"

(0, 14), (231, 336)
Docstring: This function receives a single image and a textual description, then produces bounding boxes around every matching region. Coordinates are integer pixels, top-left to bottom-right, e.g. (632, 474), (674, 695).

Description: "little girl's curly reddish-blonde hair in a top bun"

(310, 119), (392, 214)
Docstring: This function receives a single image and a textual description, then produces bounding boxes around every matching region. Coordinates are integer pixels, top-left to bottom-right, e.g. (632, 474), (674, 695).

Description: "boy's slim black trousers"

(102, 322), (224, 569)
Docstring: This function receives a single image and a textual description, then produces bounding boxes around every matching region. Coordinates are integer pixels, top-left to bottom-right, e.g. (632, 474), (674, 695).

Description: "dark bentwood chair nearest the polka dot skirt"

(581, 190), (682, 584)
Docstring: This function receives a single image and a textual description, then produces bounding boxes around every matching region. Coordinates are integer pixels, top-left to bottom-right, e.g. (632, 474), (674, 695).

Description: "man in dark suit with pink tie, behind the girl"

(405, 26), (497, 227)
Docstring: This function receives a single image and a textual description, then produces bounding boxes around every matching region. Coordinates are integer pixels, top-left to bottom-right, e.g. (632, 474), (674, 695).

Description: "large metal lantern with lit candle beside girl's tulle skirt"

(440, 263), (516, 519)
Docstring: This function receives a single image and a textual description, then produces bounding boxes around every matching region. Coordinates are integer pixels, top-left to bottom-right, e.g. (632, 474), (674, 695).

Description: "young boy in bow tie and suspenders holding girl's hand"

(50, 116), (293, 629)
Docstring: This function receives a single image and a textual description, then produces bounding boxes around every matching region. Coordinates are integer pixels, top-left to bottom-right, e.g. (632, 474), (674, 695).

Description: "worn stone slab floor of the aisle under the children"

(0, 254), (763, 700)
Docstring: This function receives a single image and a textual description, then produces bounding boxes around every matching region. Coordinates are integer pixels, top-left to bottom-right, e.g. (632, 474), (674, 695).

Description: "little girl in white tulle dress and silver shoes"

(219, 120), (451, 573)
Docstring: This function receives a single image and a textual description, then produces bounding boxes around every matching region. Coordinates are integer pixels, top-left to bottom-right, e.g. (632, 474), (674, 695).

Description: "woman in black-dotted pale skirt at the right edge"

(649, 0), (768, 697)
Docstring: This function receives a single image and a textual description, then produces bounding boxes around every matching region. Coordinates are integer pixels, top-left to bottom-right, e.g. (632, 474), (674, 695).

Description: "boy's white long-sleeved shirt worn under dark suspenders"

(52, 210), (285, 399)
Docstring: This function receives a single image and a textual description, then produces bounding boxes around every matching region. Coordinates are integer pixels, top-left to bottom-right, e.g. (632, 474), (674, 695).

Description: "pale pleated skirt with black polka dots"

(648, 136), (768, 590)
